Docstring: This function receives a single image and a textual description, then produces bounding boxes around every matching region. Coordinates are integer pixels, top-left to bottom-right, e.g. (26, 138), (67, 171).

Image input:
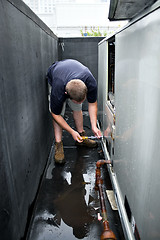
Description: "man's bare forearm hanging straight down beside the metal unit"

(88, 101), (102, 137)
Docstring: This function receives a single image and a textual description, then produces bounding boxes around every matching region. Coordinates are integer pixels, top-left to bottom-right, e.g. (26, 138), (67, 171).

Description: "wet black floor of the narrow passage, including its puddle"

(28, 111), (124, 240)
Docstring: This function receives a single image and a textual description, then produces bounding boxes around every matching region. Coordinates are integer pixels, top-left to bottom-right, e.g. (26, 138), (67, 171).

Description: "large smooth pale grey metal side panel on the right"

(114, 8), (160, 240)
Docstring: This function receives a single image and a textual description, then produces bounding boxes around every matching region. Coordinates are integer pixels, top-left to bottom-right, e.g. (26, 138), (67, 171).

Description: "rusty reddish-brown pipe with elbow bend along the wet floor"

(95, 160), (116, 240)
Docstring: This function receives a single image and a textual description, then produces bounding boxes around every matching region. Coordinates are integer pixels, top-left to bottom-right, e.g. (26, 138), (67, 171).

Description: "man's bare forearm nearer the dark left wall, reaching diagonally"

(51, 112), (82, 142)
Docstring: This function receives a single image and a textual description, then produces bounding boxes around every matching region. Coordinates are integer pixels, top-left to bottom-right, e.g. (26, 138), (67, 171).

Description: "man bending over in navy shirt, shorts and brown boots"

(47, 59), (101, 164)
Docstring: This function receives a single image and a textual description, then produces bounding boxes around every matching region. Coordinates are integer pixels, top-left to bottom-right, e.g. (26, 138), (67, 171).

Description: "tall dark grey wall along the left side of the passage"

(0, 0), (58, 240)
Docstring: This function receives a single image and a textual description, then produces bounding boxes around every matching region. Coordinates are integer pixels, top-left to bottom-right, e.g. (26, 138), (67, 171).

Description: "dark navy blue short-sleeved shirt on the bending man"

(47, 59), (97, 115)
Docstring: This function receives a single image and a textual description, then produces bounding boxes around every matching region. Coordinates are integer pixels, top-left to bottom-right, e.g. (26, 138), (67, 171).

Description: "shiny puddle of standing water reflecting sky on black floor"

(30, 149), (99, 240)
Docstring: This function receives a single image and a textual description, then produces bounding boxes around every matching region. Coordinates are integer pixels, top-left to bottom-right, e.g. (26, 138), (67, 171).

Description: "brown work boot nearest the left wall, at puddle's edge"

(54, 141), (65, 164)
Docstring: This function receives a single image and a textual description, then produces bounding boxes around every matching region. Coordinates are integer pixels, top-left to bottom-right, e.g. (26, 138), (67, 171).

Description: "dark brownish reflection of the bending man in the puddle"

(52, 148), (94, 239)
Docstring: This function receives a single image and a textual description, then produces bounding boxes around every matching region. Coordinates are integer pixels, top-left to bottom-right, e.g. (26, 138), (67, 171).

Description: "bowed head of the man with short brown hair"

(66, 79), (87, 102)
